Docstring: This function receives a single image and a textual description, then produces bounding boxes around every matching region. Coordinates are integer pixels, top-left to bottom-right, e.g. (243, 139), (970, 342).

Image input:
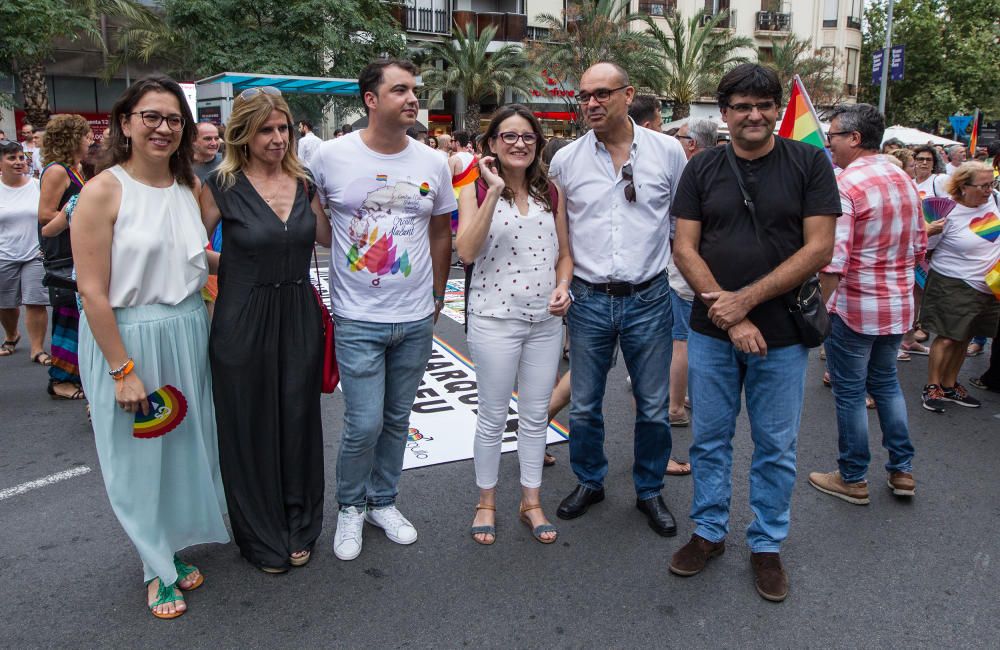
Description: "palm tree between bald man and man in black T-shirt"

(641, 11), (754, 120)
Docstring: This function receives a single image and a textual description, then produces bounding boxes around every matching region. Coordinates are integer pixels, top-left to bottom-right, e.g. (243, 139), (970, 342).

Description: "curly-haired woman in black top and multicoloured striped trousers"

(38, 115), (93, 400)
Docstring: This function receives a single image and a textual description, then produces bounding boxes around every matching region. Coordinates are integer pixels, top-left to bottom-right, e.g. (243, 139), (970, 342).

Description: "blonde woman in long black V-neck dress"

(201, 86), (331, 573)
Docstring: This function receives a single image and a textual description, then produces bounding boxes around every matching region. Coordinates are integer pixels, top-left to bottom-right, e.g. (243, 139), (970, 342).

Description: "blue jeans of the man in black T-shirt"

(688, 330), (809, 553)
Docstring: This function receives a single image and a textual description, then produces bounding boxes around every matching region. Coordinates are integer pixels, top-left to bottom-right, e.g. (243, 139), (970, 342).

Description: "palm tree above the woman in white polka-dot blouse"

(422, 24), (533, 133)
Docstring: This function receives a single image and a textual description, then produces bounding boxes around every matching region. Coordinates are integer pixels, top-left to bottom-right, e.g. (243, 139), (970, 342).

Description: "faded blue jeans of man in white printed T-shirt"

(334, 316), (434, 510)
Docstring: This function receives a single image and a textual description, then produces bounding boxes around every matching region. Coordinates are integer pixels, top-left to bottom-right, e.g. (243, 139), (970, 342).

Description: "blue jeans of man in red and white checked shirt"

(825, 314), (913, 483)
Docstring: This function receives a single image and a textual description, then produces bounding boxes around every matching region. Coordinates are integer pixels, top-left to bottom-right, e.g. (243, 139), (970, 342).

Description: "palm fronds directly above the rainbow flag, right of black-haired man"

(758, 36), (843, 107)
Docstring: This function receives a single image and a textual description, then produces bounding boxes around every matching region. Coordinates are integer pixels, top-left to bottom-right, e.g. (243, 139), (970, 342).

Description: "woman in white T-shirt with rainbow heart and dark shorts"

(920, 162), (1000, 413)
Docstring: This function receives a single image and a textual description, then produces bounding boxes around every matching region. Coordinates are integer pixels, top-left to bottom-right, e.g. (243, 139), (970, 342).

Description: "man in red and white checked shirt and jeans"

(809, 104), (927, 505)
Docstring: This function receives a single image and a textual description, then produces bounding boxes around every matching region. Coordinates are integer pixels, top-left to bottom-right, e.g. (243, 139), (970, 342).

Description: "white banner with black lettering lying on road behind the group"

(309, 264), (569, 469)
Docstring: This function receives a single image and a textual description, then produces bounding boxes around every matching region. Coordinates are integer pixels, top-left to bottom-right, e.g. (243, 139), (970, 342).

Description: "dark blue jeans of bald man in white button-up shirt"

(568, 273), (673, 499)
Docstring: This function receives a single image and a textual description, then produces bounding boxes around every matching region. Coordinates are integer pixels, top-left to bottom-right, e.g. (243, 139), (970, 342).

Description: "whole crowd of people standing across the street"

(0, 60), (1000, 618)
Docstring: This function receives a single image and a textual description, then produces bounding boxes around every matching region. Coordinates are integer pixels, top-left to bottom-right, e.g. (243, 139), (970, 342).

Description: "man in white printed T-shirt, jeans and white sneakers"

(312, 60), (456, 560)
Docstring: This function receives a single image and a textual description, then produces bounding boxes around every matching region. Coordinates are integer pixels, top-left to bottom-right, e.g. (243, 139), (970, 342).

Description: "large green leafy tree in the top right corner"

(858, 0), (1000, 130)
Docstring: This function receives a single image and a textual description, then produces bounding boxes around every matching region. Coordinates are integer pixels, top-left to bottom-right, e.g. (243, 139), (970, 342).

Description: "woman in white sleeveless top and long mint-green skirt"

(72, 76), (229, 619)
